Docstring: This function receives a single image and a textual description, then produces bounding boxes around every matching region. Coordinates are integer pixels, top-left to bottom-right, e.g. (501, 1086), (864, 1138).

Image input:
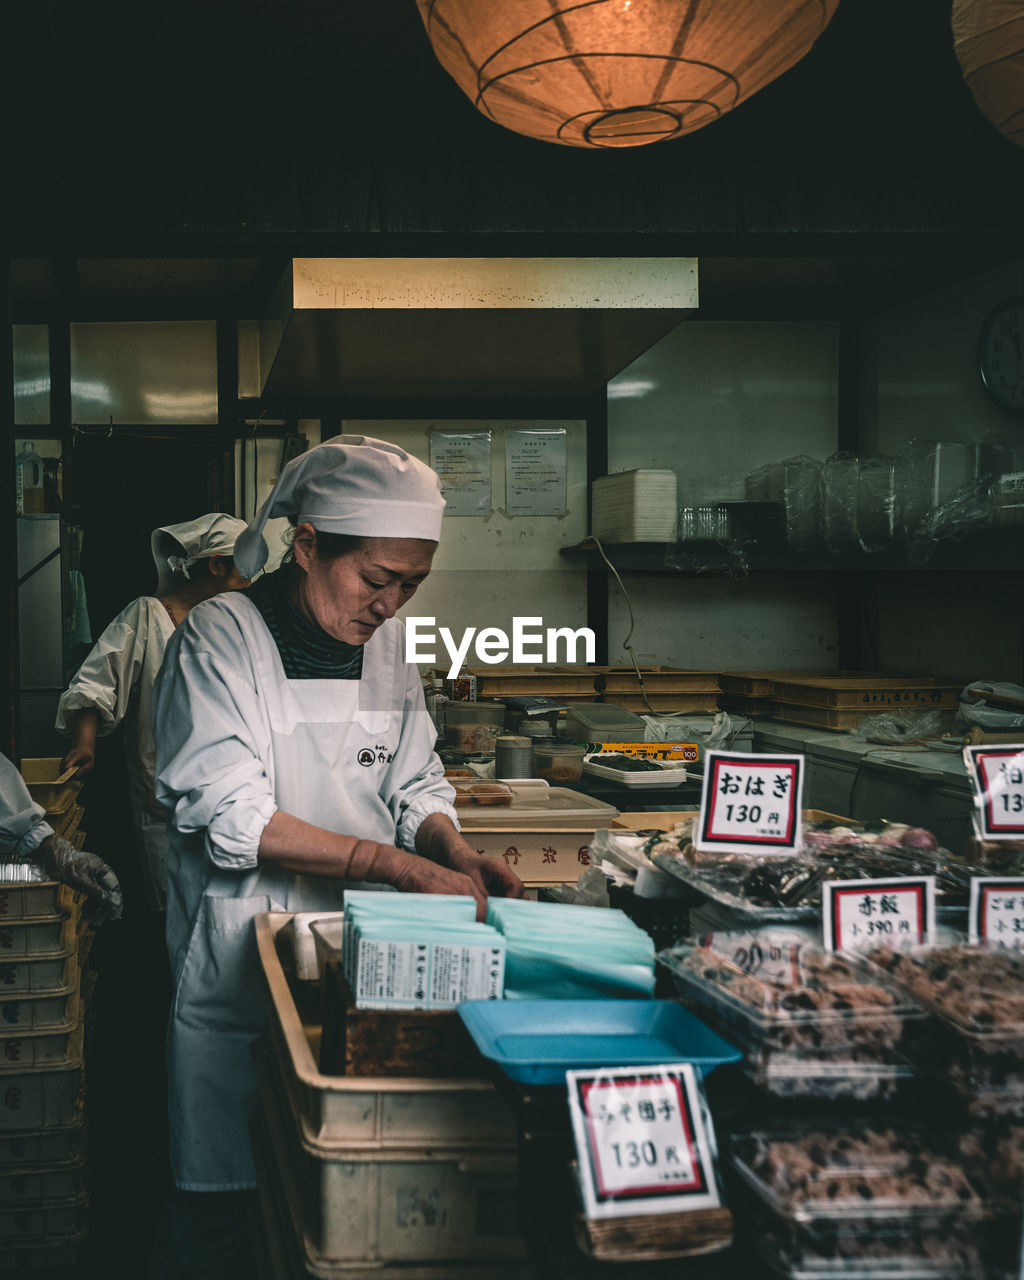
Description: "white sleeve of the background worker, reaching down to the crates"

(56, 599), (148, 736)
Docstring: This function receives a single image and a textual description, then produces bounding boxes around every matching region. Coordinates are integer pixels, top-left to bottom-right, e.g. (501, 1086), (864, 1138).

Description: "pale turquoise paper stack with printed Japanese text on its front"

(342, 890), (506, 1009)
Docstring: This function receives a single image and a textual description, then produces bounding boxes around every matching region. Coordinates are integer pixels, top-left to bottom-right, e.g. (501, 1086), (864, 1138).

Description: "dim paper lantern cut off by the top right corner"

(952, 0), (1024, 147)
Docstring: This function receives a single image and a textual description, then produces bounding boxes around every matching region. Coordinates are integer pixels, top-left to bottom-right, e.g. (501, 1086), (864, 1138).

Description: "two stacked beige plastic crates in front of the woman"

(252, 913), (535, 1280)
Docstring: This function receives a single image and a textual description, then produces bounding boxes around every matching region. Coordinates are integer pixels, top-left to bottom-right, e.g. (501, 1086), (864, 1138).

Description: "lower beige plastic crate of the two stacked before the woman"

(256, 1052), (526, 1275)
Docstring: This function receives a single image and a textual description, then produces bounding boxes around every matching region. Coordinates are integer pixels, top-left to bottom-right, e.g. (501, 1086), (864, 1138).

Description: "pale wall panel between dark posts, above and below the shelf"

(608, 320), (838, 671)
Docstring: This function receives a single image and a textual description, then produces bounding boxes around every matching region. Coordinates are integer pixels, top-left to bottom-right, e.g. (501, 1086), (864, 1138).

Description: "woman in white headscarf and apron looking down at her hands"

(150, 435), (524, 1277)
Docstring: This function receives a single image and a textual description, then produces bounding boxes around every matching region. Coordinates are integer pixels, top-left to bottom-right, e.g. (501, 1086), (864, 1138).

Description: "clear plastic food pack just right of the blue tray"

(657, 931), (925, 1101)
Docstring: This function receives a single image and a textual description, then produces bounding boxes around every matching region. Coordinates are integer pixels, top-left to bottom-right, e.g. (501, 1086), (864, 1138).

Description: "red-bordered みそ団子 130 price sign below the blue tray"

(566, 1062), (721, 1219)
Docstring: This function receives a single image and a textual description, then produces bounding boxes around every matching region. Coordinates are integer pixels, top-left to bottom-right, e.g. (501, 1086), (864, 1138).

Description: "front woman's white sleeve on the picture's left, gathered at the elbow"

(154, 602), (278, 870)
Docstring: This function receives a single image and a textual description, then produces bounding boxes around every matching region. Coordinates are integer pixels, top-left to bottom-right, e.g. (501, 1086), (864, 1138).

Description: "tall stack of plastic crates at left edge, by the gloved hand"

(0, 760), (92, 1274)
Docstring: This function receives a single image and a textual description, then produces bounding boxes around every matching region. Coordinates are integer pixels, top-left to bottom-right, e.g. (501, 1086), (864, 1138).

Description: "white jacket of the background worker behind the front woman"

(56, 595), (174, 909)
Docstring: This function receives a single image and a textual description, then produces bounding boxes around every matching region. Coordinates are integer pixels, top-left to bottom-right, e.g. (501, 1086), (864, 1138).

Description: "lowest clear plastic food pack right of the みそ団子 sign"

(730, 1123), (988, 1280)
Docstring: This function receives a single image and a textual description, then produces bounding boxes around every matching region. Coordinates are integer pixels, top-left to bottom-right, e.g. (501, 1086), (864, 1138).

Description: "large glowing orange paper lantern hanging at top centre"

(416, 0), (838, 148)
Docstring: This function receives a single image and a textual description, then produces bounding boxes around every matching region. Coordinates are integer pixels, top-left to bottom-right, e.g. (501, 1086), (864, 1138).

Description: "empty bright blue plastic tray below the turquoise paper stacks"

(458, 1000), (742, 1084)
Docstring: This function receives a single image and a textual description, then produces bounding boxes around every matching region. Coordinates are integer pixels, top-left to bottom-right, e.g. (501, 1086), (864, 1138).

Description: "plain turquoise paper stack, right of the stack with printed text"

(488, 897), (654, 1000)
